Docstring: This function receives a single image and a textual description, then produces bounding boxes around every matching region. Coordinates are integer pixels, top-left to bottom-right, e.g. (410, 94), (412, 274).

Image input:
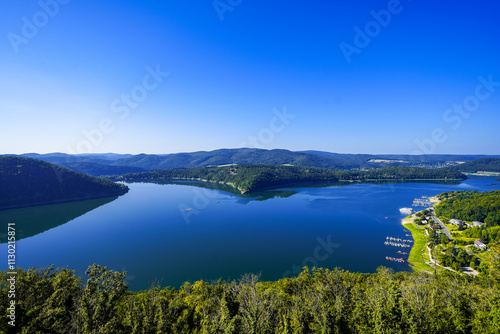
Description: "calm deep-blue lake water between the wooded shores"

(0, 176), (500, 291)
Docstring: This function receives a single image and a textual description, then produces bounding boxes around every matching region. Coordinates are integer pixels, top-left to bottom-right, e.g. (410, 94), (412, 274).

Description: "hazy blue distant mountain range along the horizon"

(4, 148), (500, 176)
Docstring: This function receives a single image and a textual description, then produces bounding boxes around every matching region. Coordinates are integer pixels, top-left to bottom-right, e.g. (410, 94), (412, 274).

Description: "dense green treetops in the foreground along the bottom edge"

(0, 265), (500, 334)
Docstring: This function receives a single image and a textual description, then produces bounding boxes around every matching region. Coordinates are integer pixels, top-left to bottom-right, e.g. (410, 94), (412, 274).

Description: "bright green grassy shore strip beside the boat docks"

(402, 214), (434, 272)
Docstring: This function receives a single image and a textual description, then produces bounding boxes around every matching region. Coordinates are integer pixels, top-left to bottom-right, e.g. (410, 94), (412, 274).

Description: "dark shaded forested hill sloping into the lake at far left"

(0, 157), (128, 209)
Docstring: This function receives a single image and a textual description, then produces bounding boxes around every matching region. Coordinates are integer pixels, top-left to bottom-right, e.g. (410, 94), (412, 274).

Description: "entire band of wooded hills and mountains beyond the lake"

(0, 149), (500, 209)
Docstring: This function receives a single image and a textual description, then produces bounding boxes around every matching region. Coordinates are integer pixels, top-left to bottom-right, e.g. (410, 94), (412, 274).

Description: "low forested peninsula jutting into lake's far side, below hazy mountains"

(111, 165), (466, 193)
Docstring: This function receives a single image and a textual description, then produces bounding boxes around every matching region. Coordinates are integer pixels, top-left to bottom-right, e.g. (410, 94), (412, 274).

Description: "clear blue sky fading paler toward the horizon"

(0, 0), (500, 154)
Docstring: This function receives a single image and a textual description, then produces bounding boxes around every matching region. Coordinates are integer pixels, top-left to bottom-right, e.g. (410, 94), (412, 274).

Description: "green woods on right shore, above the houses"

(436, 190), (500, 227)
